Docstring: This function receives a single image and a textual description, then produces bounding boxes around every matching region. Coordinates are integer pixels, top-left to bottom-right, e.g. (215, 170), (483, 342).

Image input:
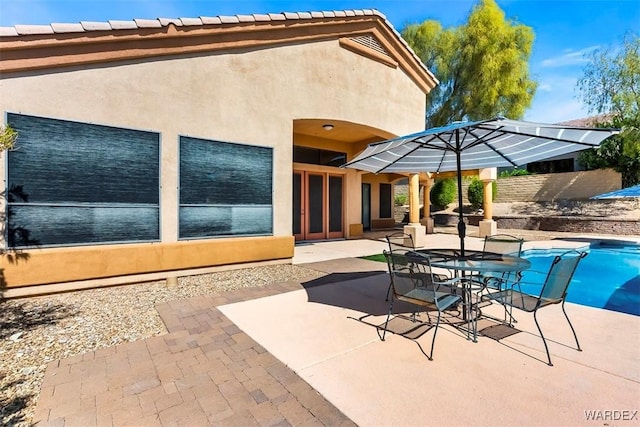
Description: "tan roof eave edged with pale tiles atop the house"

(0, 9), (438, 93)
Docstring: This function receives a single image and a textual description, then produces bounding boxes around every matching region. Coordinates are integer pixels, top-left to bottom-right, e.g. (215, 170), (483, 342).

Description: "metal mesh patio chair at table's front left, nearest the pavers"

(378, 250), (462, 360)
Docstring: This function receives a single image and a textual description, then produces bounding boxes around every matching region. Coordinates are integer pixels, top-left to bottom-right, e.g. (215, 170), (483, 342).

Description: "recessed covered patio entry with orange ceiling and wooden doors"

(292, 119), (398, 241)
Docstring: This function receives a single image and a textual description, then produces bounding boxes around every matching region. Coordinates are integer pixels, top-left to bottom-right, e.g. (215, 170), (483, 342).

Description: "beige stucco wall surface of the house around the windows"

(0, 40), (425, 290)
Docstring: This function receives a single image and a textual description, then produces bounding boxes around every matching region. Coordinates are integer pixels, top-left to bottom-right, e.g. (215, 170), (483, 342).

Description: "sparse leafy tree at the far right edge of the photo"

(577, 33), (640, 188)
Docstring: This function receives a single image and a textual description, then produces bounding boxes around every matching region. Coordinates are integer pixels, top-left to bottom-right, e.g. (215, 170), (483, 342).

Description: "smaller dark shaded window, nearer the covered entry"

(179, 137), (273, 238)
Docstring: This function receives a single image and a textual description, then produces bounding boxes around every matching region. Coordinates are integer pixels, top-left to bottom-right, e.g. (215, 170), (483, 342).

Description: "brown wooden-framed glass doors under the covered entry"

(293, 170), (344, 240)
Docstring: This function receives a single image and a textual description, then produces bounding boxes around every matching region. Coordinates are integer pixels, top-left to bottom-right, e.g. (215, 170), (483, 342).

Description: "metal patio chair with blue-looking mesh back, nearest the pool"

(486, 250), (587, 366)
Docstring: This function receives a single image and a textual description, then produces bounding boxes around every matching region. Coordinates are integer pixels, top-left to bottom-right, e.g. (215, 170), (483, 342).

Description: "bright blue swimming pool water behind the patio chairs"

(522, 240), (640, 316)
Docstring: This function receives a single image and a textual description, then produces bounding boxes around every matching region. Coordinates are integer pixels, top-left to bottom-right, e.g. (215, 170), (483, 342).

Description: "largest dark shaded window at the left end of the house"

(7, 113), (160, 247)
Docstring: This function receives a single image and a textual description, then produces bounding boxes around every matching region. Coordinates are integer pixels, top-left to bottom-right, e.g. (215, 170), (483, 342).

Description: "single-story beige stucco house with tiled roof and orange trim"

(0, 10), (438, 296)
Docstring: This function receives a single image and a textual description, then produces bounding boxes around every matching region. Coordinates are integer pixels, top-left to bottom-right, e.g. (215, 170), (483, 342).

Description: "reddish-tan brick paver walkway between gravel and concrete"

(35, 282), (354, 427)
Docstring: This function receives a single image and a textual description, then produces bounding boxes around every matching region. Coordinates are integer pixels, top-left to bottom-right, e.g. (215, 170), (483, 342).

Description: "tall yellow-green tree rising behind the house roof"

(402, 0), (537, 127)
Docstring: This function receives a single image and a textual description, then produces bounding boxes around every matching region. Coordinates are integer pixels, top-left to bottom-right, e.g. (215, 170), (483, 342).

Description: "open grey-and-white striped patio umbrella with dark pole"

(343, 117), (618, 255)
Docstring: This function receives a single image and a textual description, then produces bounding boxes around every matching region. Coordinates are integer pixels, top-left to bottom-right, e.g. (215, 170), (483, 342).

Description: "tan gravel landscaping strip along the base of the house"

(0, 264), (324, 426)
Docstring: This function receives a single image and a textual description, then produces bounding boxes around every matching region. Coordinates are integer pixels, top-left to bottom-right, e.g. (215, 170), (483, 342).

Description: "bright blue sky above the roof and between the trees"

(0, 0), (640, 123)
